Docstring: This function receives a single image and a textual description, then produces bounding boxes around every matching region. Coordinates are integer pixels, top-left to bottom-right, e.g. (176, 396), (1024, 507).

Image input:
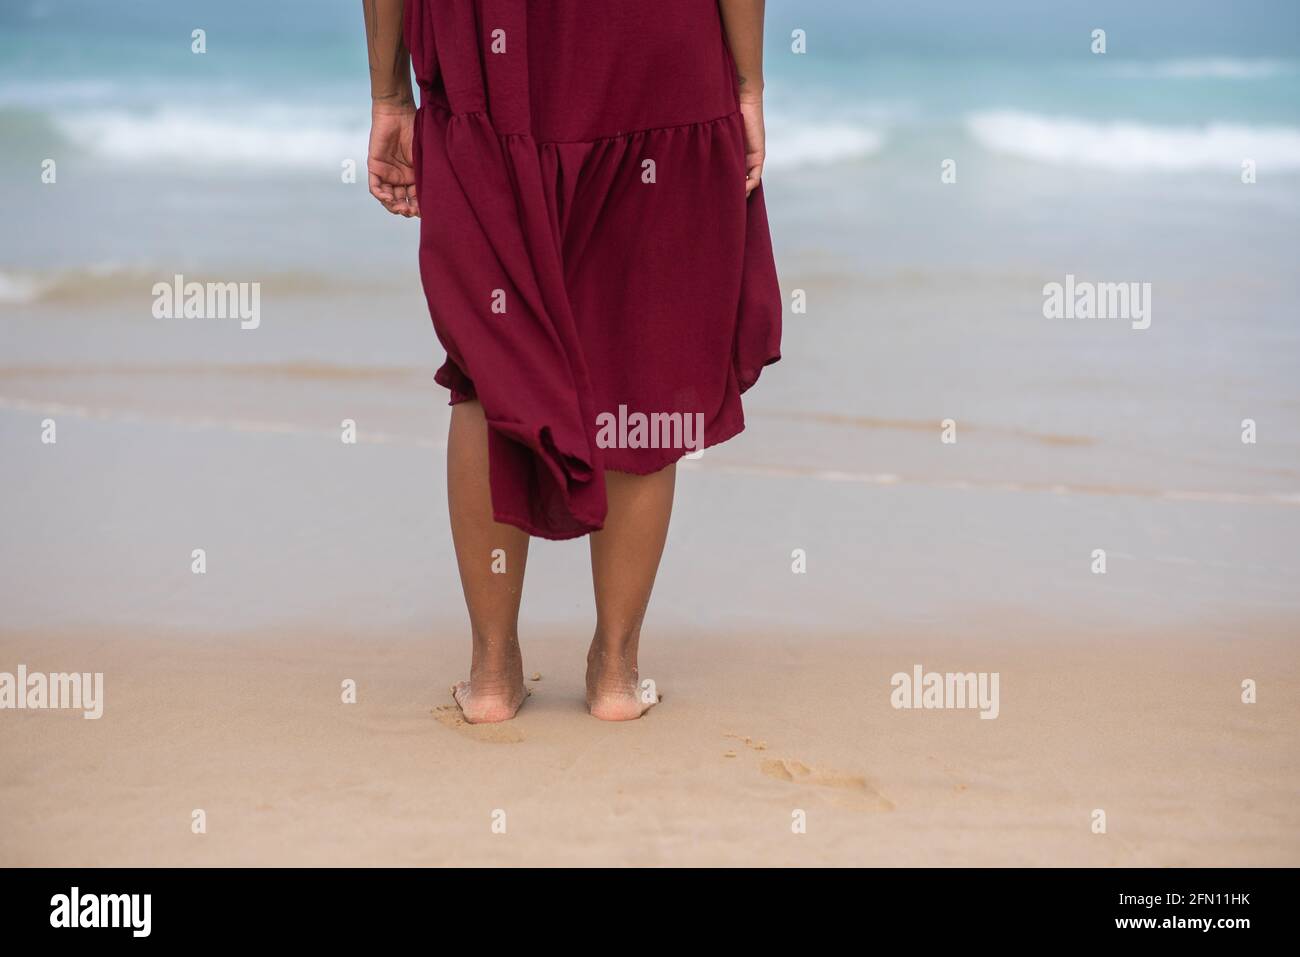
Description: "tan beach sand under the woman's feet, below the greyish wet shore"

(0, 622), (1300, 866)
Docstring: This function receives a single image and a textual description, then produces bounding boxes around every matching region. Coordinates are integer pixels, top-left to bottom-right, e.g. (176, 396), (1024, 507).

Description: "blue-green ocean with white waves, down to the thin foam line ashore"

(0, 0), (1300, 556)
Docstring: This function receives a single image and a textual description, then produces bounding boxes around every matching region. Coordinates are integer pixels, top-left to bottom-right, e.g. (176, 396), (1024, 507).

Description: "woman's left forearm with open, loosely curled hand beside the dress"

(361, 0), (420, 216)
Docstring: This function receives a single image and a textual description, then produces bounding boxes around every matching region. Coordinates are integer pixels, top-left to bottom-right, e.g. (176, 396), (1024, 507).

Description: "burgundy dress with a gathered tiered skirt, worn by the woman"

(406, 0), (781, 538)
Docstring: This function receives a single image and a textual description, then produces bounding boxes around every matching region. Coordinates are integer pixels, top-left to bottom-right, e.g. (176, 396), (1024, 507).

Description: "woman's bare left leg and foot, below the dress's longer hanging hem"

(447, 402), (528, 723)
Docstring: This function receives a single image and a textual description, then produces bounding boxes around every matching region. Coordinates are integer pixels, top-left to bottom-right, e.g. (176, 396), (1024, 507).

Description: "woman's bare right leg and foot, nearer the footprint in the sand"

(586, 465), (677, 720)
